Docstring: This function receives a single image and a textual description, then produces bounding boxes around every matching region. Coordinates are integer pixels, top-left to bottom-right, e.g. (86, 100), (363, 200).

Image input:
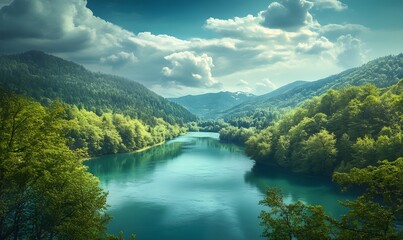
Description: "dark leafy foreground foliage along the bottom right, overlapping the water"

(259, 157), (403, 240)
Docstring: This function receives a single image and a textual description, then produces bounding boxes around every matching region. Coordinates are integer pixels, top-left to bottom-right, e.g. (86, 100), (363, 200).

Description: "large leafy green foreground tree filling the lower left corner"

(0, 93), (109, 239)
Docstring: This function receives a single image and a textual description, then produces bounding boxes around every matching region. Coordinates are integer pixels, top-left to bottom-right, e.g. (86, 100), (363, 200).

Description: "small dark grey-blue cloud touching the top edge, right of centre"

(261, 0), (313, 30)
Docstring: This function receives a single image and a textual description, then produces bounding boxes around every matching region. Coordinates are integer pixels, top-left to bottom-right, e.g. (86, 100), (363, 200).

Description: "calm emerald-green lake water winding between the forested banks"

(86, 133), (354, 240)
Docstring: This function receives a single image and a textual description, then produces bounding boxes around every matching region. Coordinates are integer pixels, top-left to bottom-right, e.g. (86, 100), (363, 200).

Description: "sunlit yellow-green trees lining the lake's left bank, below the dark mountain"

(64, 101), (186, 156)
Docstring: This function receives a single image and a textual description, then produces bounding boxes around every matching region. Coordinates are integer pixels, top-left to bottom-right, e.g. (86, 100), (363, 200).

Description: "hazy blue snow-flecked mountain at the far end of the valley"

(170, 92), (256, 119)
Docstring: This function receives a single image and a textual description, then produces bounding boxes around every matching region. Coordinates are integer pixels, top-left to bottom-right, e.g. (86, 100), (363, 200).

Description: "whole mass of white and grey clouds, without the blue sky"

(0, 0), (372, 96)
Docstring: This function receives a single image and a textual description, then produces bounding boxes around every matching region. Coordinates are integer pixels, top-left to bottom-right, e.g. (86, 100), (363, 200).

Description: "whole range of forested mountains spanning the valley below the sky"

(0, 51), (403, 123)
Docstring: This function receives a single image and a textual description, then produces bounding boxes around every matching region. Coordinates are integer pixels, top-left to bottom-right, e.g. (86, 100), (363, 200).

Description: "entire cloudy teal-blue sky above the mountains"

(0, 0), (403, 97)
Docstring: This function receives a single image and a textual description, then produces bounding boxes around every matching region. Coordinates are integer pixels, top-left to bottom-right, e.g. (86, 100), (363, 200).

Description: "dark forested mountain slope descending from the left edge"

(0, 51), (196, 123)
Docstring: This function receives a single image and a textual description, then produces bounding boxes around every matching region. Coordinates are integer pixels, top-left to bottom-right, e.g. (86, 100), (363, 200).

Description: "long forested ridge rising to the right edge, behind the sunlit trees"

(223, 54), (403, 118)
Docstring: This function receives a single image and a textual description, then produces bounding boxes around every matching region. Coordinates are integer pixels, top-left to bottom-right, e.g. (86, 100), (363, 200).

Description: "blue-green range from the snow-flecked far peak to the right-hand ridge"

(170, 54), (403, 120)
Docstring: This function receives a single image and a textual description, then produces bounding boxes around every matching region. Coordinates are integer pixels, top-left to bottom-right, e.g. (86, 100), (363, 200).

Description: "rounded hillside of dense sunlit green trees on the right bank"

(246, 80), (403, 175)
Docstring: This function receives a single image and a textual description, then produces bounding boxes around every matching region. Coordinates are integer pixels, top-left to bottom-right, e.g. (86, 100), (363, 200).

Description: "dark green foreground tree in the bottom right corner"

(333, 157), (403, 239)
